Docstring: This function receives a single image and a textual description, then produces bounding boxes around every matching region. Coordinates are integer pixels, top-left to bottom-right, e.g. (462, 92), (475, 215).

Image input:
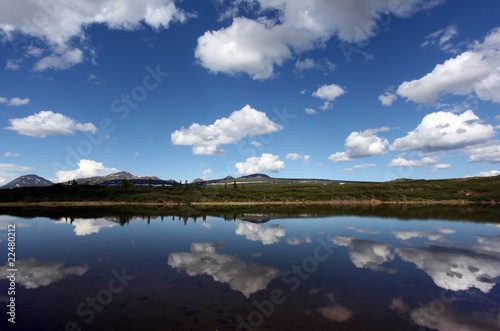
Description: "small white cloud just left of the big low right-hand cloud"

(328, 127), (389, 162)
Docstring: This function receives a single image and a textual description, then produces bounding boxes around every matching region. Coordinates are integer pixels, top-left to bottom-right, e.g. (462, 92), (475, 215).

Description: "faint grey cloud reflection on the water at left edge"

(0, 259), (89, 289)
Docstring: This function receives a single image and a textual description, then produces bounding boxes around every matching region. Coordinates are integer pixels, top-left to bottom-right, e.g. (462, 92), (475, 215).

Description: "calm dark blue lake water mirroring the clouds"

(0, 209), (500, 330)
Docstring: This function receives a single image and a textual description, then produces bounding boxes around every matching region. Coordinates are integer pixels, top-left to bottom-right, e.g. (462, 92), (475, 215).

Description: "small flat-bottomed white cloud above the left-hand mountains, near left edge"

(5, 111), (97, 138)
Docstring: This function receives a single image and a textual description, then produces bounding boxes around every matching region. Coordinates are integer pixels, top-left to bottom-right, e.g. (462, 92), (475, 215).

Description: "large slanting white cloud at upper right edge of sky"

(397, 28), (500, 104)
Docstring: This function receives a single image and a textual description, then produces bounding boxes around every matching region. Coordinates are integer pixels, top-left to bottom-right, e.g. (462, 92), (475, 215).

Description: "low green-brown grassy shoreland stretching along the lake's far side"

(0, 176), (500, 204)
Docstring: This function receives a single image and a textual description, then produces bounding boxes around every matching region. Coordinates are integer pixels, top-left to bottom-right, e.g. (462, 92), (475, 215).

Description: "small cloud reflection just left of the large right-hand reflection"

(330, 236), (394, 271)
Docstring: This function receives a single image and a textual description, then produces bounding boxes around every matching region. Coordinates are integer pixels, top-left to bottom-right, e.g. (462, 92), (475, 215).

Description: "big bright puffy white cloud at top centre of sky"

(195, 17), (313, 79)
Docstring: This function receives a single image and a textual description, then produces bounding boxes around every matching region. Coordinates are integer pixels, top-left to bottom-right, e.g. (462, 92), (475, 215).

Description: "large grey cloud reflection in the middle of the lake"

(168, 242), (280, 298)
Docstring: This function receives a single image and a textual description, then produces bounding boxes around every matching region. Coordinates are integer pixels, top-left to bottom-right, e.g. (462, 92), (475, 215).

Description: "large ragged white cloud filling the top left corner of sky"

(0, 0), (189, 71)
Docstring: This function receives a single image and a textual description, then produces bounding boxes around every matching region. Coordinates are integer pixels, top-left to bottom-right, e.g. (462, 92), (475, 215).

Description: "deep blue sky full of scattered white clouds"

(0, 0), (500, 185)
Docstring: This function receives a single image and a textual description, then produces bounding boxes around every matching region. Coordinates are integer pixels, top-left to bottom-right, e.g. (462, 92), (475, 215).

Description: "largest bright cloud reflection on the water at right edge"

(396, 245), (500, 293)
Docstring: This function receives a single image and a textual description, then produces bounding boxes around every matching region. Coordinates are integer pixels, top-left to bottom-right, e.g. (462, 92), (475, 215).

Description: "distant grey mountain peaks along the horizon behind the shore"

(0, 171), (354, 189)
